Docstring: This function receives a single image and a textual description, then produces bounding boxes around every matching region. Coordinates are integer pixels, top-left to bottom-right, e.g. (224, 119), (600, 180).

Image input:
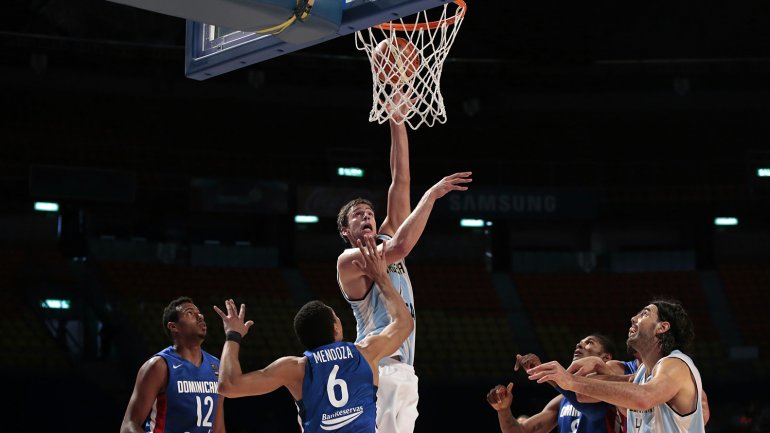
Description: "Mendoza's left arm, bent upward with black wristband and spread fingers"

(214, 299), (304, 398)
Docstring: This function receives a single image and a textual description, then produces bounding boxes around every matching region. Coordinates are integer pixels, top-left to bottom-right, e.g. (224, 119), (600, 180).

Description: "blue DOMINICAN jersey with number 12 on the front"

(144, 346), (219, 433)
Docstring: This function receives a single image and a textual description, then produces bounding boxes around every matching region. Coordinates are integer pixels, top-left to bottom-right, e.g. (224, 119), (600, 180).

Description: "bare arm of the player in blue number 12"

(120, 356), (168, 433)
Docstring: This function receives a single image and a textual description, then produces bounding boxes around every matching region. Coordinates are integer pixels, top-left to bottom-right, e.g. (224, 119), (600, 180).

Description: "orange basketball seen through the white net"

(372, 37), (420, 84)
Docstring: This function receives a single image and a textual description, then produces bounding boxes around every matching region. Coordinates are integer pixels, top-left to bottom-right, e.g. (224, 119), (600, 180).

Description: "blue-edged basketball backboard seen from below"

(185, 0), (451, 80)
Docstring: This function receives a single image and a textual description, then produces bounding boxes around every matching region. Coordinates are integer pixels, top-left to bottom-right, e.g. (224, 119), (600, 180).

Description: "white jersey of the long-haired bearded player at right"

(626, 350), (705, 433)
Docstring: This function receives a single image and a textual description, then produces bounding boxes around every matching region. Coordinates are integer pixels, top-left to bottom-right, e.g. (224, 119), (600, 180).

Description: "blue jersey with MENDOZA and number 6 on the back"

(297, 341), (377, 433)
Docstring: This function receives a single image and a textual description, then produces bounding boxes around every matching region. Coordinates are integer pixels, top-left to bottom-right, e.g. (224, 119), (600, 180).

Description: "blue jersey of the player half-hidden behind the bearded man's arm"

(556, 386), (615, 433)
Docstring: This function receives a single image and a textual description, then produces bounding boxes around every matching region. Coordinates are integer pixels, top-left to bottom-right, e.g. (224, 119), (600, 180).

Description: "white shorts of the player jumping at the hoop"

(377, 358), (419, 433)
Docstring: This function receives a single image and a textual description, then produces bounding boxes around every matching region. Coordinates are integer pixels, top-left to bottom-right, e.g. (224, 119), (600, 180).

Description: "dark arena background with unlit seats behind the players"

(0, 0), (770, 433)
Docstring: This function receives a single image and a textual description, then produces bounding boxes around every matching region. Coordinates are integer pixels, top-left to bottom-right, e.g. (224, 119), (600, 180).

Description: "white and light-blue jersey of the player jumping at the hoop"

(337, 234), (417, 365)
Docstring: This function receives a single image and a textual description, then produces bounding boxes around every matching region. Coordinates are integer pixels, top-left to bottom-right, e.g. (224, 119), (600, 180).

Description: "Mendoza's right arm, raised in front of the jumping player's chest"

(355, 237), (414, 364)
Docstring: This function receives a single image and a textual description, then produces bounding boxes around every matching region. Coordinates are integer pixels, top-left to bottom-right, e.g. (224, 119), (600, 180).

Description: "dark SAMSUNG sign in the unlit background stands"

(433, 188), (596, 219)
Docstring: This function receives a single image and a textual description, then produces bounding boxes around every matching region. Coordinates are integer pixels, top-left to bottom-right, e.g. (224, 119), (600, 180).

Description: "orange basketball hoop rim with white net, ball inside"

(356, 0), (466, 129)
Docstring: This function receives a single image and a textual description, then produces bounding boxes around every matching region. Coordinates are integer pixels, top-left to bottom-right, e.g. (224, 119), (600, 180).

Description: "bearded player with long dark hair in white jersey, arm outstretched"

(527, 299), (705, 433)
